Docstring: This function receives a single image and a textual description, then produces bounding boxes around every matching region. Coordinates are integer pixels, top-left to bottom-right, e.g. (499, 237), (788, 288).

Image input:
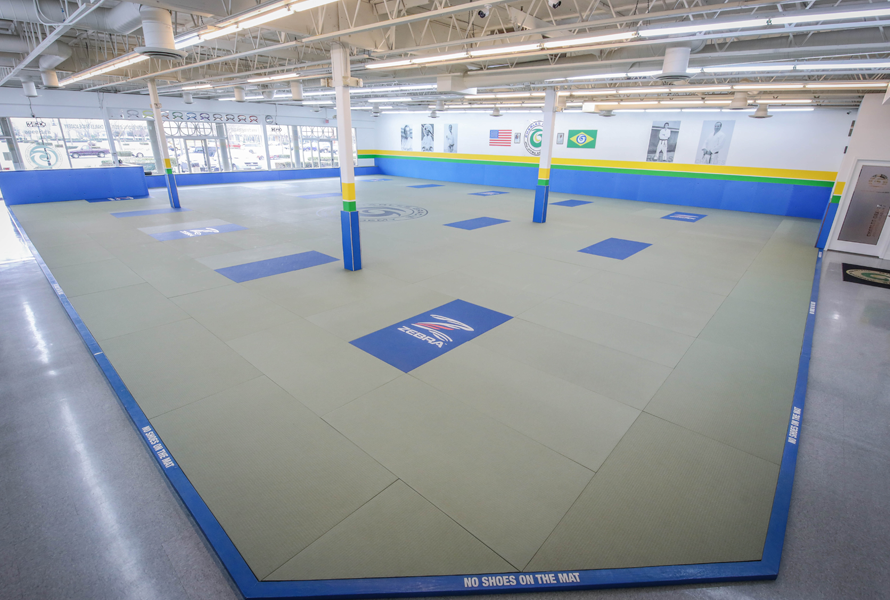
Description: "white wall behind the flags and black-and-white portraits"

(376, 109), (852, 172)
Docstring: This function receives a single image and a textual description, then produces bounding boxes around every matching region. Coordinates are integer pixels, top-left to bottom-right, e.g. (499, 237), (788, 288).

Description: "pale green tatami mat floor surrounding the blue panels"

(13, 177), (818, 580)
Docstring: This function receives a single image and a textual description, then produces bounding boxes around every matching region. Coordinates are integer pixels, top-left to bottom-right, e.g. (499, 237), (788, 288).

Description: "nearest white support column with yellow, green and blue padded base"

(331, 44), (362, 271)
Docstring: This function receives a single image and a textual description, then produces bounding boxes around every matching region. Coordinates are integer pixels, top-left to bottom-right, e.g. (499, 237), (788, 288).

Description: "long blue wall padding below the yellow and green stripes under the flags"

(375, 156), (831, 219)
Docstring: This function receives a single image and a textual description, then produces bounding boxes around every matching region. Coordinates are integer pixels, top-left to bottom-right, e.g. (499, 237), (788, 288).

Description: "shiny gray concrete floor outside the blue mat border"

(0, 195), (890, 599)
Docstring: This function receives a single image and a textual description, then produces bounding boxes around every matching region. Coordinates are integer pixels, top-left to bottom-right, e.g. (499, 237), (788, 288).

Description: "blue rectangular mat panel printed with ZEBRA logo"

(349, 300), (513, 373)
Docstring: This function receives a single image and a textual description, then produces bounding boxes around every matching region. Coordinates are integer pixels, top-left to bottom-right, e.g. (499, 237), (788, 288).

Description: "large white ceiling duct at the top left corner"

(0, 0), (142, 33)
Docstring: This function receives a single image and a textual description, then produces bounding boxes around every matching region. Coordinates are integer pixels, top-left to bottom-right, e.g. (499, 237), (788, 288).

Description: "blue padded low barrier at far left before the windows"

(0, 167), (147, 205)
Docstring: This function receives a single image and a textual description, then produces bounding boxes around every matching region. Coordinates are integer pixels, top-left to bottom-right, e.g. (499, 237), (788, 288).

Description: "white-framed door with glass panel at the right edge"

(829, 161), (890, 258)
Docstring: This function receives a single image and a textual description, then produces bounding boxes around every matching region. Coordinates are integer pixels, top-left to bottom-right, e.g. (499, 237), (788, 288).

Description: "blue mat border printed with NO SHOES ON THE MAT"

(8, 203), (822, 600)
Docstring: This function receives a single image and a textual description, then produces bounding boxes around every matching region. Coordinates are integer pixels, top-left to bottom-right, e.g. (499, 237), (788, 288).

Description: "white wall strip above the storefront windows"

(0, 88), (377, 166)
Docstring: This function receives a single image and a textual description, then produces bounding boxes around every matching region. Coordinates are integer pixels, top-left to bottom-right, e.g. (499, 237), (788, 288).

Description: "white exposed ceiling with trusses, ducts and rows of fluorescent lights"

(0, 0), (890, 110)
